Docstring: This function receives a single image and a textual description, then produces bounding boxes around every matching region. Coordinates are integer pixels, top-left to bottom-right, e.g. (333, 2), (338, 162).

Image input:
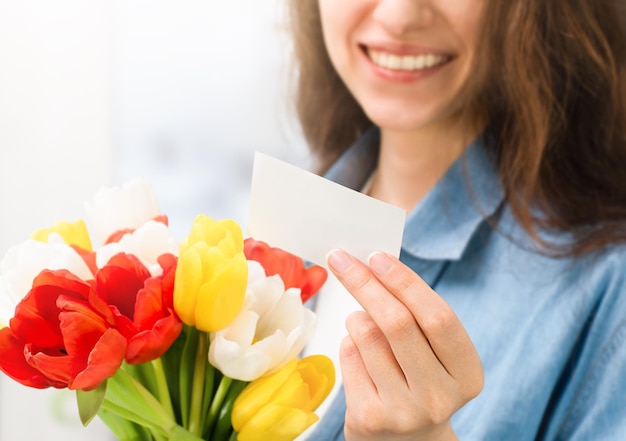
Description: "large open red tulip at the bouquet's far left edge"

(0, 270), (126, 390)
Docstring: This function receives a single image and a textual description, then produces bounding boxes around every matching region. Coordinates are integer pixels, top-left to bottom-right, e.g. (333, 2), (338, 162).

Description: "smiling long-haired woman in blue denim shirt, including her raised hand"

(290, 0), (626, 441)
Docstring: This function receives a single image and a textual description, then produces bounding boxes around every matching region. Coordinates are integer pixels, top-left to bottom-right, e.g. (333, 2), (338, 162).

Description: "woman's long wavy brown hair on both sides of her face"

(288, 0), (626, 255)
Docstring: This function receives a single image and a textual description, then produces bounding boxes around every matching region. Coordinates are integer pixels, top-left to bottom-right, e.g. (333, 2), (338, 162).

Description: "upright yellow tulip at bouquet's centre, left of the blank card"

(174, 215), (248, 332)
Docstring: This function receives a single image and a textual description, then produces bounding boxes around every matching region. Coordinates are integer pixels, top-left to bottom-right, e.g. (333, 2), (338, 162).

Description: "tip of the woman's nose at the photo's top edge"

(373, 0), (435, 35)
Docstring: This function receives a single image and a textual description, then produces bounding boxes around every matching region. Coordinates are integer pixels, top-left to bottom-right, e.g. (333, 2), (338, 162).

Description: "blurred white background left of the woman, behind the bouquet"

(0, 0), (309, 441)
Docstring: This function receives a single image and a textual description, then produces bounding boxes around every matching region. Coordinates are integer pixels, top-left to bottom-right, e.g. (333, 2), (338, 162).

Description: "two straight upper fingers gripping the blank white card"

(328, 250), (482, 394)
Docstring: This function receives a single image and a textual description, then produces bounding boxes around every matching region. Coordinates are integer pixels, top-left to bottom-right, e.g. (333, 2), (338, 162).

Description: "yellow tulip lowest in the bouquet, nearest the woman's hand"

(232, 355), (335, 441)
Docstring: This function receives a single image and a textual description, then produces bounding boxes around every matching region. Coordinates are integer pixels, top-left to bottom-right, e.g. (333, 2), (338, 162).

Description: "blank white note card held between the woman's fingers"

(247, 152), (406, 266)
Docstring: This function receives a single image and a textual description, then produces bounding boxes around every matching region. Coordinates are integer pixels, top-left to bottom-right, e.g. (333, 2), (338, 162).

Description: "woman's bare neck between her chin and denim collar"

(369, 115), (478, 212)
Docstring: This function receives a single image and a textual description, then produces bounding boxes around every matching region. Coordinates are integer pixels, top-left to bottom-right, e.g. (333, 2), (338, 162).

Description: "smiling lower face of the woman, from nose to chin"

(319, 0), (483, 138)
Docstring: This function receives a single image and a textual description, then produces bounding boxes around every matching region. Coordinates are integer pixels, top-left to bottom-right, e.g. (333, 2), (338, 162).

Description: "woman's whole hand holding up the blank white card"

(328, 250), (483, 441)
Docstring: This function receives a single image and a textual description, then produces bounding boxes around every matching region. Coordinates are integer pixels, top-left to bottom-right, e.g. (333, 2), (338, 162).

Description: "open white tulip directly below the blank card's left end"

(209, 261), (315, 381)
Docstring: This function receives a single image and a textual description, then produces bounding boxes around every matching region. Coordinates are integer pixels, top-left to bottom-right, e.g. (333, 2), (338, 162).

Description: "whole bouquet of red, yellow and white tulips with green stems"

(0, 180), (335, 441)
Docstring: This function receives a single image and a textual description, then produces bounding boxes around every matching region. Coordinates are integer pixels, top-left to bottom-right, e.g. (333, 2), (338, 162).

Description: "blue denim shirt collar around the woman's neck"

(326, 127), (504, 260)
